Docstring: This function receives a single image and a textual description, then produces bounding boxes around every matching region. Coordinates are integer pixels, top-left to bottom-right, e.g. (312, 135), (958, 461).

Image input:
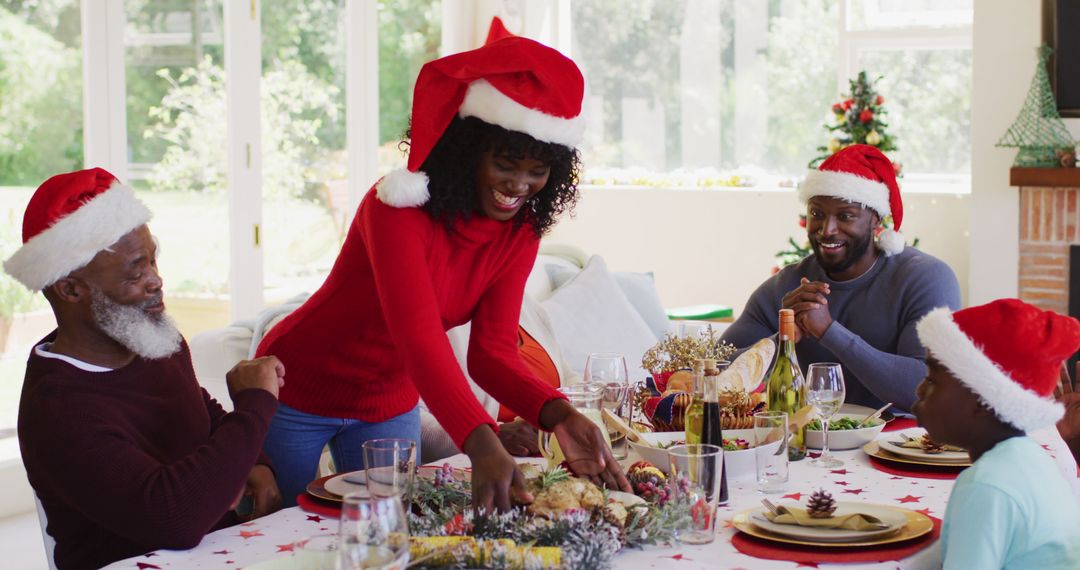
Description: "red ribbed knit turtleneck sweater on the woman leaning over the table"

(258, 190), (561, 447)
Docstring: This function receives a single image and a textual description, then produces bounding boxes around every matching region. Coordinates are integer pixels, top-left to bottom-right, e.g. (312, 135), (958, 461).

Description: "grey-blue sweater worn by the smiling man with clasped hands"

(724, 247), (960, 410)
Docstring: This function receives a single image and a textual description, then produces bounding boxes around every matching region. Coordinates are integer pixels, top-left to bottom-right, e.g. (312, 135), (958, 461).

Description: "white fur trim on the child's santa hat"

(916, 308), (1065, 432)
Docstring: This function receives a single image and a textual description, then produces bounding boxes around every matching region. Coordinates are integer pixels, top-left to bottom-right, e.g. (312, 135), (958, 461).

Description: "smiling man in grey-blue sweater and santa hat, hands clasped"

(724, 145), (960, 411)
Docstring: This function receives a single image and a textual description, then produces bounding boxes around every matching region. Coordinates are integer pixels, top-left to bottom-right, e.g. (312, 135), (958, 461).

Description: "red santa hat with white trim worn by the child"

(916, 299), (1080, 432)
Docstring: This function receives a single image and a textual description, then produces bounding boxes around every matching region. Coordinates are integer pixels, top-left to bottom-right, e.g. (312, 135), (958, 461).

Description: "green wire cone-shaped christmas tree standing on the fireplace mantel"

(997, 45), (1075, 168)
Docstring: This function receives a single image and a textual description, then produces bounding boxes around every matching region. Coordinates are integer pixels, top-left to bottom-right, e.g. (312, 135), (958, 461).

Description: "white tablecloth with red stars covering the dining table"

(101, 419), (1071, 570)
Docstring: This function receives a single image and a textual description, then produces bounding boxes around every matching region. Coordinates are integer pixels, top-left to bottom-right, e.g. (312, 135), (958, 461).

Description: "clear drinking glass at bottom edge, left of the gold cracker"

(338, 492), (409, 570)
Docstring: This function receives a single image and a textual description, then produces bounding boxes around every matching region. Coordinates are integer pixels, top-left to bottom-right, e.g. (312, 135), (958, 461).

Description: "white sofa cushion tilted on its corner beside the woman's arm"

(541, 256), (658, 380)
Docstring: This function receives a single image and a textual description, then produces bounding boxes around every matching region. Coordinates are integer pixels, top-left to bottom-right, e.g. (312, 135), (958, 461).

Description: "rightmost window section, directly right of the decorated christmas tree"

(840, 0), (973, 192)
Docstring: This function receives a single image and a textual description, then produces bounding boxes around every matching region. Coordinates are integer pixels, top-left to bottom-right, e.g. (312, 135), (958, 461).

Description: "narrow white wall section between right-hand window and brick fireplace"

(969, 0), (1041, 304)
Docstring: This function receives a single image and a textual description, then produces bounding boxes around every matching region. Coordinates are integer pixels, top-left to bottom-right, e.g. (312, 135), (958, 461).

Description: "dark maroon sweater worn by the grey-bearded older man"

(18, 334), (278, 569)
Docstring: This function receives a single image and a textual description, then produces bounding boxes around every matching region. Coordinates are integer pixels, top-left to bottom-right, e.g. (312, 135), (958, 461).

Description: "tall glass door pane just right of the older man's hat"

(123, 0), (229, 336)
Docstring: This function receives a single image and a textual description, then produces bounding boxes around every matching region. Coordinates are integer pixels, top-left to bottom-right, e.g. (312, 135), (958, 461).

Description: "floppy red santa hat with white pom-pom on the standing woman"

(376, 18), (585, 207)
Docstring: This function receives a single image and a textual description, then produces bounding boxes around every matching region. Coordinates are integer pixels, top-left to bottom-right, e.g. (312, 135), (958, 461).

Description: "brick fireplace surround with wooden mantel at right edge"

(1010, 168), (1080, 316)
